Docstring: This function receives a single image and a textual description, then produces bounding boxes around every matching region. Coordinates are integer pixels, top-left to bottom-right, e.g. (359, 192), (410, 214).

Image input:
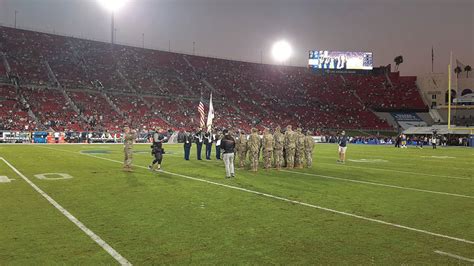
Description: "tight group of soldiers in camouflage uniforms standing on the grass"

(236, 126), (314, 172)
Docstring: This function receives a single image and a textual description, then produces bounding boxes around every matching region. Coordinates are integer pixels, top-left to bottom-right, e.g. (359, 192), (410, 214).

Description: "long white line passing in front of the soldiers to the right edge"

(36, 149), (474, 245)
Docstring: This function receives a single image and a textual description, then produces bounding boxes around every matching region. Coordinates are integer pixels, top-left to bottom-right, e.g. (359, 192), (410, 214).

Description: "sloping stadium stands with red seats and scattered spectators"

(0, 27), (427, 132)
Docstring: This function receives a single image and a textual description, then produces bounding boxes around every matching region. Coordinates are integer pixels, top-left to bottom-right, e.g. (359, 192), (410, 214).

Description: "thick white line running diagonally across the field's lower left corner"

(0, 157), (132, 265)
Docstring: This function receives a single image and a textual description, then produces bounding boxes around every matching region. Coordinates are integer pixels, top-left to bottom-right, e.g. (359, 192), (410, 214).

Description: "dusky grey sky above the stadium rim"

(0, 0), (474, 75)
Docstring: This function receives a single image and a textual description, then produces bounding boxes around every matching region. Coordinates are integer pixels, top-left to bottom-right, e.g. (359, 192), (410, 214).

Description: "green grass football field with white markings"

(0, 144), (474, 265)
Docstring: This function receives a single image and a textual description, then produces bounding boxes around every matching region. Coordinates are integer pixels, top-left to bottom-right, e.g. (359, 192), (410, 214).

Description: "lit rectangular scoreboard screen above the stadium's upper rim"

(308, 51), (373, 70)
